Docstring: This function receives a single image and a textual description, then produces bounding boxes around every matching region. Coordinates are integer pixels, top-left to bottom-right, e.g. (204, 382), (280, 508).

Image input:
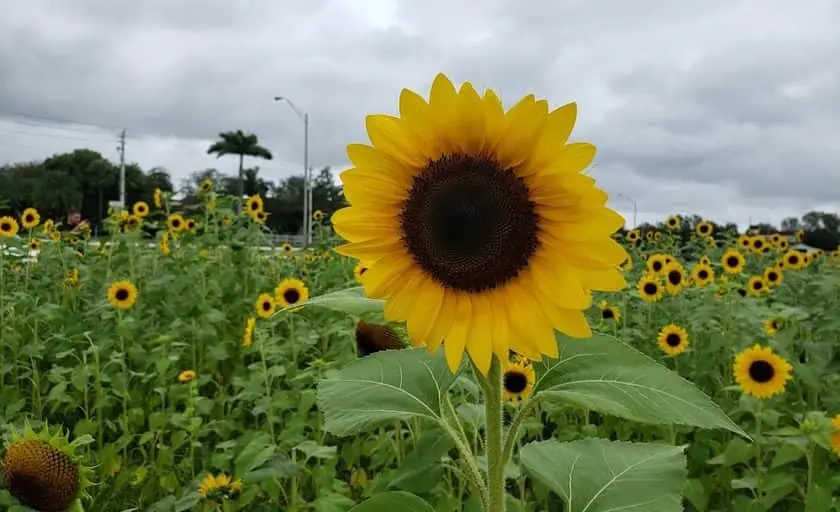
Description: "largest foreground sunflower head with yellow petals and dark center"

(332, 74), (627, 373)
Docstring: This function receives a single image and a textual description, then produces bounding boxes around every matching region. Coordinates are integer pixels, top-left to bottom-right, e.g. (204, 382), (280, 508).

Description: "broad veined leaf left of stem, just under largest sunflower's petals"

(318, 348), (455, 435)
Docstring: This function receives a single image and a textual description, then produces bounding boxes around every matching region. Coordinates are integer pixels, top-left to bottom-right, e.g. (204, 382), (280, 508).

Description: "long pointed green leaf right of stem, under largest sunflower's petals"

(534, 333), (749, 437)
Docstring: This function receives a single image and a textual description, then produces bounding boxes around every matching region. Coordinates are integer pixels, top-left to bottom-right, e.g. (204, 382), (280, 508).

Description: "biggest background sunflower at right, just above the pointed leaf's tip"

(733, 344), (793, 398)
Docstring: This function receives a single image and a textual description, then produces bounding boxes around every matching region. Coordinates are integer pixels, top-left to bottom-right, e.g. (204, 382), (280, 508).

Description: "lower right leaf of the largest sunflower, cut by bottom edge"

(519, 439), (687, 512)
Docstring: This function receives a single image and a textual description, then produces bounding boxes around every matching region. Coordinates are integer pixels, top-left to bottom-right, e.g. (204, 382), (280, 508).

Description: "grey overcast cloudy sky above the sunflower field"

(0, 0), (840, 225)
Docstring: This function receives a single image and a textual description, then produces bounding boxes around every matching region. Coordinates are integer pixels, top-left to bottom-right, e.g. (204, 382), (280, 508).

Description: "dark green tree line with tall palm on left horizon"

(0, 130), (345, 233)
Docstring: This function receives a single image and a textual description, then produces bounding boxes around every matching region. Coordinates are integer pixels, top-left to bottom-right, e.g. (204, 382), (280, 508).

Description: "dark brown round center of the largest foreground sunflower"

(400, 155), (539, 293)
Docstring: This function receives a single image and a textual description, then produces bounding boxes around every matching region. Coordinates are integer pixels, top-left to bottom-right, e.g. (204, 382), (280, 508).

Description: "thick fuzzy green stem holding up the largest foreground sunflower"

(479, 357), (507, 512)
